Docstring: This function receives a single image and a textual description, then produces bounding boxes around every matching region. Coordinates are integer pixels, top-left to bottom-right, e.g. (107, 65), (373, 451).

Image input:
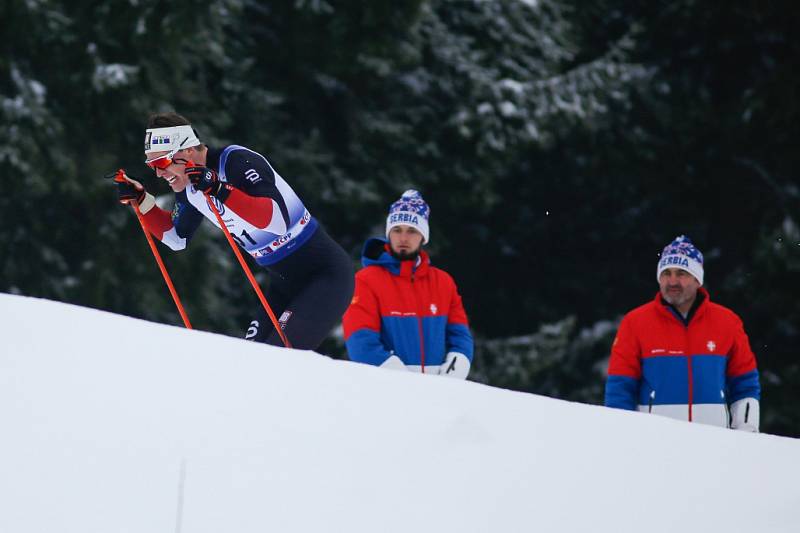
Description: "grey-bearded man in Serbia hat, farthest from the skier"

(605, 235), (761, 432)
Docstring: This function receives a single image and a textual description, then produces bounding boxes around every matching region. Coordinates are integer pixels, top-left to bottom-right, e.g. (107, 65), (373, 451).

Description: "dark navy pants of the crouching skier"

(245, 225), (355, 350)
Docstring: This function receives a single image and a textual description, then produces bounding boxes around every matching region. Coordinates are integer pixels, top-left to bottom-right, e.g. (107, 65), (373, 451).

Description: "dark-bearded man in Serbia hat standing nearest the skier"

(342, 189), (473, 379)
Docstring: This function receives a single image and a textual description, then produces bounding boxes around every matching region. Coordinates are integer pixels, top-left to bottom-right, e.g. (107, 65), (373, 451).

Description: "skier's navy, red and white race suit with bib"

(139, 145), (354, 350)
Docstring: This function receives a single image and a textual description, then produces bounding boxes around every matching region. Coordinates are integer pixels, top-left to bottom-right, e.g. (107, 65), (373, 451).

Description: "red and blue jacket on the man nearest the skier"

(342, 239), (473, 374)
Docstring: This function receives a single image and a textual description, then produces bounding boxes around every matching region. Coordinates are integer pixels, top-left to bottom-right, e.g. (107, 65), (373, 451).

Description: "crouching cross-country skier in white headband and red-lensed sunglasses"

(118, 113), (354, 349)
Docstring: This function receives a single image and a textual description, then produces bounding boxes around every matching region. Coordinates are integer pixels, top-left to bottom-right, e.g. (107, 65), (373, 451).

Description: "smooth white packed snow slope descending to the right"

(0, 294), (800, 533)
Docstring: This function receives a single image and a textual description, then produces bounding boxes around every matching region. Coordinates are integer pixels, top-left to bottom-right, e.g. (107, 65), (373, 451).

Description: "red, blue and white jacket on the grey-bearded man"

(605, 287), (761, 427)
